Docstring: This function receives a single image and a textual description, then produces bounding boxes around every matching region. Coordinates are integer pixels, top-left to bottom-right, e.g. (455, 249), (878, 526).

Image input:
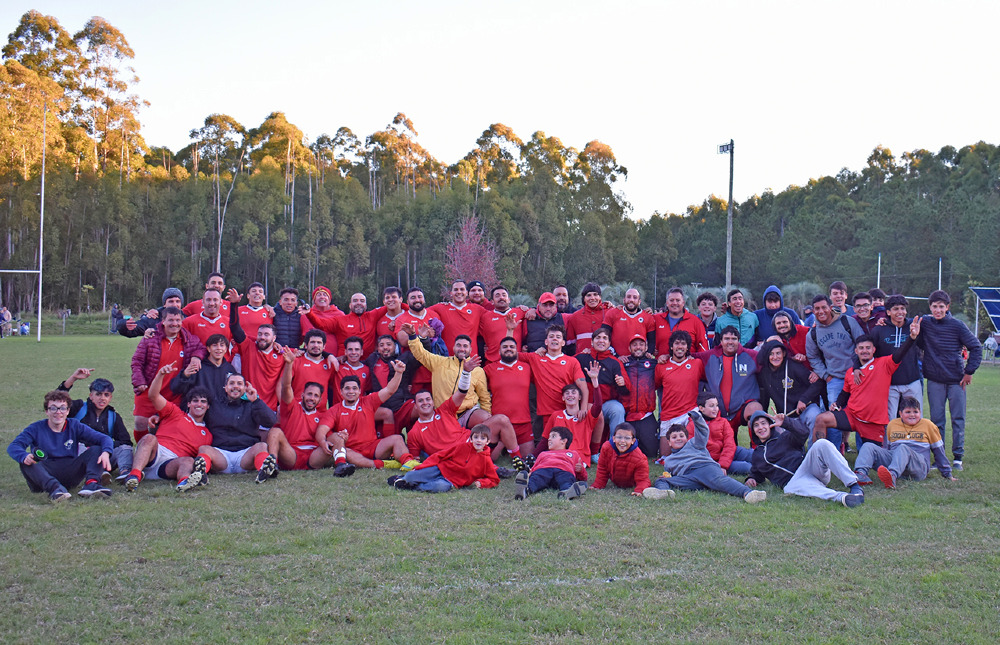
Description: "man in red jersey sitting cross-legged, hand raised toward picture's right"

(316, 361), (420, 470)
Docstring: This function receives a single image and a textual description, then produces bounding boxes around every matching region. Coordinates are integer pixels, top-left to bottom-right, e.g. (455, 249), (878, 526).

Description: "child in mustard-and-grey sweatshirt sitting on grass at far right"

(854, 396), (955, 488)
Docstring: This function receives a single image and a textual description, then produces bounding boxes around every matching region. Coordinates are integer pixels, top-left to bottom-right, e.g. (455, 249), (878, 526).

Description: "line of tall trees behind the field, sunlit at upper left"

(0, 11), (1000, 320)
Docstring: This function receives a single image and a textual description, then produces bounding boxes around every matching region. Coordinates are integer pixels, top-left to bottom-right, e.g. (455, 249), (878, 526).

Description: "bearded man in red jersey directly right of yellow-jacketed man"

(484, 336), (535, 455)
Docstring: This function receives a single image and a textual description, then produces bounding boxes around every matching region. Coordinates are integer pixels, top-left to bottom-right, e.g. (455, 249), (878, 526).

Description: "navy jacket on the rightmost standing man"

(917, 312), (983, 385)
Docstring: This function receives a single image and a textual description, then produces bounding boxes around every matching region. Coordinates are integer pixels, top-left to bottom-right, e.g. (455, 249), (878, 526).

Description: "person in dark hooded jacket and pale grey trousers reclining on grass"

(747, 412), (865, 508)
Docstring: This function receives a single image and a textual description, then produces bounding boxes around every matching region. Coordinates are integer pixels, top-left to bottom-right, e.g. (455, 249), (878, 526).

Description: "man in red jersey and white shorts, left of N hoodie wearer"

(656, 332), (705, 455)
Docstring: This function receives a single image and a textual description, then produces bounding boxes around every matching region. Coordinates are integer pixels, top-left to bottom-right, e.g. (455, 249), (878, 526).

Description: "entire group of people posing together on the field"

(8, 273), (982, 507)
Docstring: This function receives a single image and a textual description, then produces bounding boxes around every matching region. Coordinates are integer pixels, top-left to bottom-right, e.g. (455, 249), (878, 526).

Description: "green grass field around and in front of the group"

(0, 336), (1000, 643)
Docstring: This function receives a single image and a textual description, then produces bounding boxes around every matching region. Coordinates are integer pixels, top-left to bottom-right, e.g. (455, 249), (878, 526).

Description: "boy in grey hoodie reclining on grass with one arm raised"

(653, 408), (767, 504)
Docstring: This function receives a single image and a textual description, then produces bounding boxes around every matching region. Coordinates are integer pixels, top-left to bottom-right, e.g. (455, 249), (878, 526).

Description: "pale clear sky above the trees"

(0, 0), (1000, 219)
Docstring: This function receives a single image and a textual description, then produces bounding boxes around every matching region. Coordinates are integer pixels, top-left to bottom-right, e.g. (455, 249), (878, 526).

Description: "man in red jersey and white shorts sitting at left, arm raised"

(125, 363), (212, 493)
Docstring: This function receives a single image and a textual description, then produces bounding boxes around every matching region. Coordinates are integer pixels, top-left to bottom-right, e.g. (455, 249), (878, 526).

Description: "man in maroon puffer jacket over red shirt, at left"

(132, 307), (207, 441)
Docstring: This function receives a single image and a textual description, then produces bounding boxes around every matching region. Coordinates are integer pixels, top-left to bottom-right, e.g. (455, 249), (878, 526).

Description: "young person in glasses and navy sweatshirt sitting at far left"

(7, 390), (113, 503)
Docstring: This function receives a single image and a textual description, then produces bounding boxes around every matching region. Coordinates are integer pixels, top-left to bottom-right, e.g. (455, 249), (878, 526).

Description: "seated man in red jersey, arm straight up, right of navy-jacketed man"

(267, 350), (354, 477)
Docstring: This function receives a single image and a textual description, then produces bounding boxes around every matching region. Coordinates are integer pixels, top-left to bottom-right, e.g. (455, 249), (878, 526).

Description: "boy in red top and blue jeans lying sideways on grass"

(389, 423), (500, 493)
